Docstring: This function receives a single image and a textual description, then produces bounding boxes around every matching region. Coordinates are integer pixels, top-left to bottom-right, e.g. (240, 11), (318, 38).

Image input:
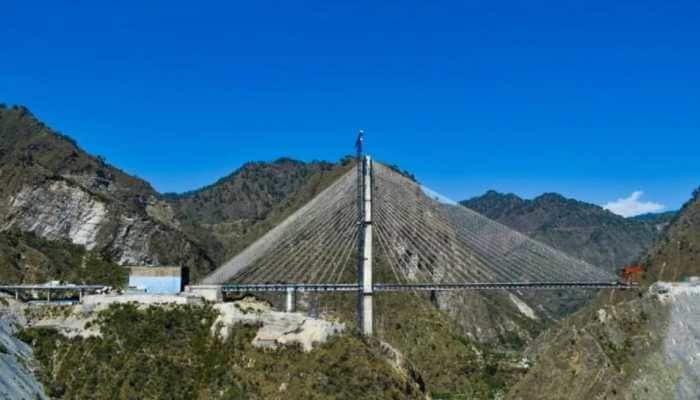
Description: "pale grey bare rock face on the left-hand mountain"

(0, 178), (210, 269)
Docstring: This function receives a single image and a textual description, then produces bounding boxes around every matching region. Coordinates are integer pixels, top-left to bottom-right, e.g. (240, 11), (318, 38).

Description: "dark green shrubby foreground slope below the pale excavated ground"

(20, 305), (425, 400)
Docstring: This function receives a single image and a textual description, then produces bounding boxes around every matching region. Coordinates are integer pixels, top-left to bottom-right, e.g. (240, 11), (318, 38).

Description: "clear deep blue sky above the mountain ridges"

(0, 0), (700, 214)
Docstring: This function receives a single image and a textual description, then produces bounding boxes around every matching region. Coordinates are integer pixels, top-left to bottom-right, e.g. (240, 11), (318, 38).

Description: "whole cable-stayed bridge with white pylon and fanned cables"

(194, 138), (631, 335)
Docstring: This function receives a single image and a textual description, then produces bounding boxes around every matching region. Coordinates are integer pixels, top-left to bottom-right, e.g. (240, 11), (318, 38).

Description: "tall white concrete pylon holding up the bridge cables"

(360, 156), (374, 336)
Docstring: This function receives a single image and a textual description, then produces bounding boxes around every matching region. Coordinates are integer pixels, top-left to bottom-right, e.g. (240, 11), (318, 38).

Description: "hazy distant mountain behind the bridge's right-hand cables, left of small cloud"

(461, 191), (658, 273)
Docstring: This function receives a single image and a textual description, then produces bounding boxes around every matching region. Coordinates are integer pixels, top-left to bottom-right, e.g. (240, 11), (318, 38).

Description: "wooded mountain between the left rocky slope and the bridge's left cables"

(165, 158), (350, 265)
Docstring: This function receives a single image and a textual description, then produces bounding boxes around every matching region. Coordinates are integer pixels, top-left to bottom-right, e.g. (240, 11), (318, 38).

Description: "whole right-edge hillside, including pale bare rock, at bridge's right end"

(507, 186), (700, 400)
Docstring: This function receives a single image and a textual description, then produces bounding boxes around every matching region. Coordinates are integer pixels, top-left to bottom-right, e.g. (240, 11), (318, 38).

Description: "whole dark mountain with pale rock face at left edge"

(0, 107), (214, 280)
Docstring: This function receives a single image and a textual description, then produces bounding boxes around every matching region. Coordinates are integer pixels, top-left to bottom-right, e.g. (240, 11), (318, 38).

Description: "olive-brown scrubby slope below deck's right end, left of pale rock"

(507, 291), (675, 400)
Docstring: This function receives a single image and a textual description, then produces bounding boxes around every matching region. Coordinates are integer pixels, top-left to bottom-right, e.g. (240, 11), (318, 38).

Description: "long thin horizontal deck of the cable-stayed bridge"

(222, 282), (639, 293)
